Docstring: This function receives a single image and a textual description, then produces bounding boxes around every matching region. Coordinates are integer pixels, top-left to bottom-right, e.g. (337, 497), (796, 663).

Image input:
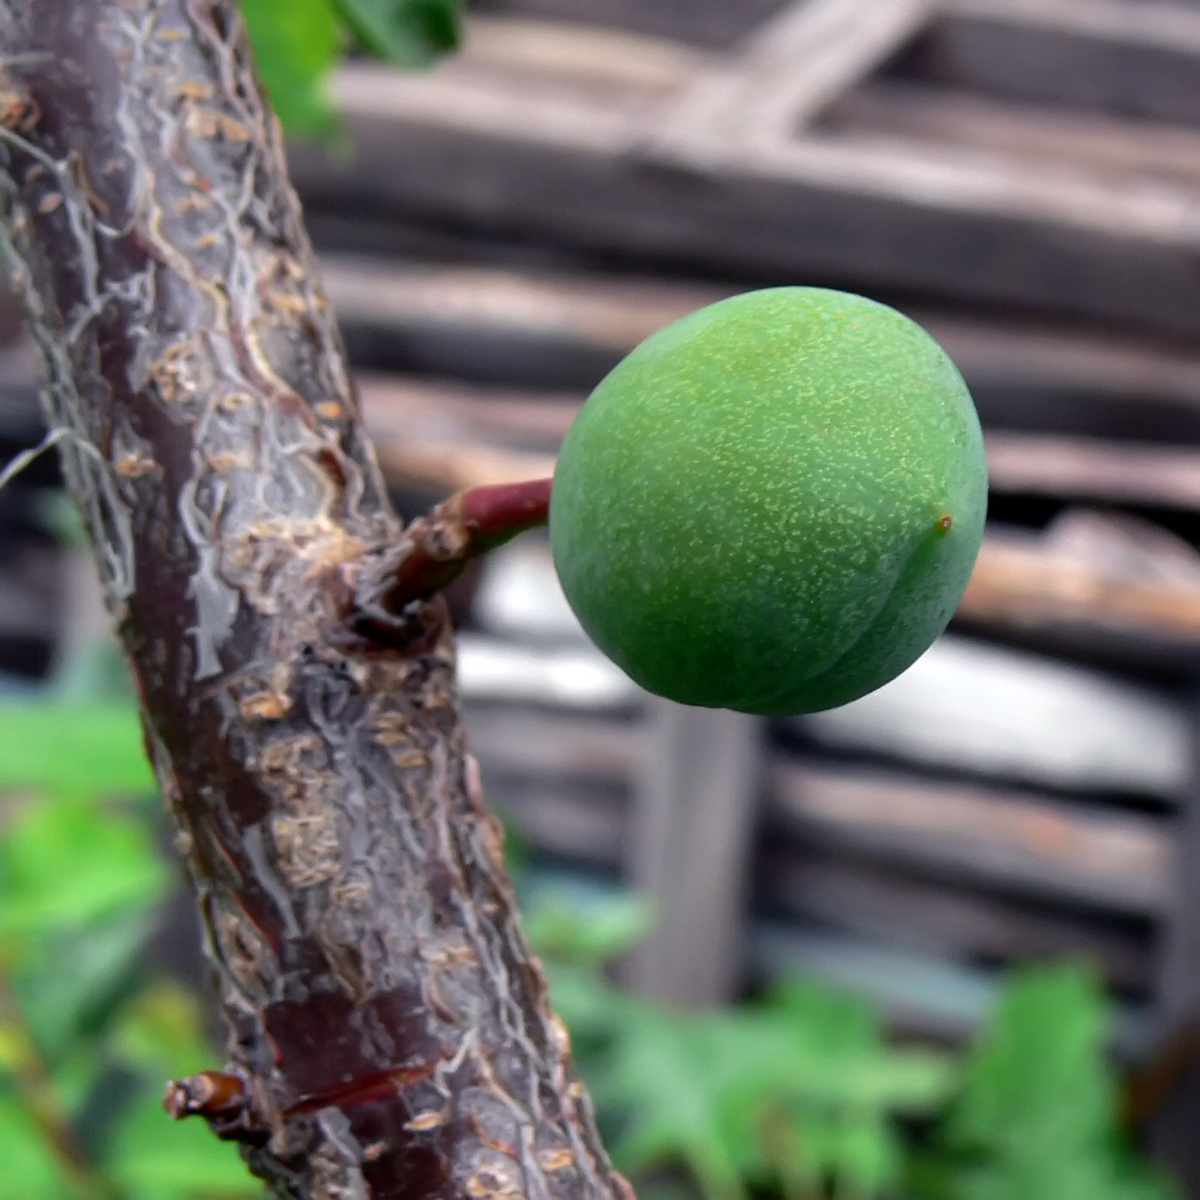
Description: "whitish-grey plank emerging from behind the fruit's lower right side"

(788, 636), (1190, 803)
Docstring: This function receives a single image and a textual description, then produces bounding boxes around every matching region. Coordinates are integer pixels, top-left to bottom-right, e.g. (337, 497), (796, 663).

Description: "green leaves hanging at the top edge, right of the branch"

(241, 0), (462, 140)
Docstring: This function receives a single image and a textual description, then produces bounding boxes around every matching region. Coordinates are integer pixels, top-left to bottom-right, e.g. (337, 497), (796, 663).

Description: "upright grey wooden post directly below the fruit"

(624, 697), (761, 1004)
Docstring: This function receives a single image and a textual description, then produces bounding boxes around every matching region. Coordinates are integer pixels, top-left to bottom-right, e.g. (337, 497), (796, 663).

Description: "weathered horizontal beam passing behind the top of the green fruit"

(325, 256), (1200, 443)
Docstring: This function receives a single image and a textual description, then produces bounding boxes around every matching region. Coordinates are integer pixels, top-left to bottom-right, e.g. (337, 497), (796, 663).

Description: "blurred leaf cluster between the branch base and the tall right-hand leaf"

(527, 894), (958, 1200)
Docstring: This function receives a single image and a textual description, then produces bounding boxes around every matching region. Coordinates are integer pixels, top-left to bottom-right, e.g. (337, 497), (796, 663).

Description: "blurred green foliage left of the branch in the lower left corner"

(0, 698), (258, 1200)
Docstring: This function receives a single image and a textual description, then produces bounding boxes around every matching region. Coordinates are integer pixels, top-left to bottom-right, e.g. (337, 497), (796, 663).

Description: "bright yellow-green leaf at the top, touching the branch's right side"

(241, 0), (342, 139)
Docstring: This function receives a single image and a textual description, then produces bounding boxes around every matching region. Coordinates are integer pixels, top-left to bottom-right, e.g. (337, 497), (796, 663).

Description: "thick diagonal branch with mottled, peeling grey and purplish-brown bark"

(0, 7), (628, 1200)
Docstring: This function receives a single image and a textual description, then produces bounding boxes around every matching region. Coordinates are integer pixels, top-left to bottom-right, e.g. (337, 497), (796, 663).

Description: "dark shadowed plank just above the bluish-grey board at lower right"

(756, 847), (1157, 995)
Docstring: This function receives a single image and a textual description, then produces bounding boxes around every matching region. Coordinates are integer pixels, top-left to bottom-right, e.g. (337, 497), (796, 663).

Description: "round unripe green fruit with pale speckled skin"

(550, 288), (988, 715)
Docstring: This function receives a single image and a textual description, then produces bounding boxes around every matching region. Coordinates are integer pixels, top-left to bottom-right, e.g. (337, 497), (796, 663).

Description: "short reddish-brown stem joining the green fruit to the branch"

(356, 479), (553, 640)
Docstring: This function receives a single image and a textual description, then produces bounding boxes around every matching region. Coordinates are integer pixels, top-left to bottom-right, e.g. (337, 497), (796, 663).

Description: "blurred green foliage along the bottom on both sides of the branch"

(0, 686), (1174, 1200)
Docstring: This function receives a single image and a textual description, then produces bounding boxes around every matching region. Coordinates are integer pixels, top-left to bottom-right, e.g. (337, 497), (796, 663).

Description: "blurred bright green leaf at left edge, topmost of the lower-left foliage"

(0, 702), (155, 796)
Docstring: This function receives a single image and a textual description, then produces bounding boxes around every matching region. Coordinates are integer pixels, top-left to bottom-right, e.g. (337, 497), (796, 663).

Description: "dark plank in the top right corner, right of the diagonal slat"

(912, 0), (1200, 124)
